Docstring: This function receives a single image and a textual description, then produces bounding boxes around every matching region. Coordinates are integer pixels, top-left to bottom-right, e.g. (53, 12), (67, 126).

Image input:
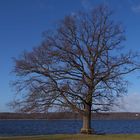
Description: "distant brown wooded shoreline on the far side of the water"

(0, 112), (140, 120)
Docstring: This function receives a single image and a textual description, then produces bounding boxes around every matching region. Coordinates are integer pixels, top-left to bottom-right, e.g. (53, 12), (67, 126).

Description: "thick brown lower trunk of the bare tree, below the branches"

(81, 104), (92, 134)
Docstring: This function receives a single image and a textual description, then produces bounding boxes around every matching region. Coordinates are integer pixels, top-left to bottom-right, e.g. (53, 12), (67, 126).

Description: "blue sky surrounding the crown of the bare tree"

(0, 0), (140, 112)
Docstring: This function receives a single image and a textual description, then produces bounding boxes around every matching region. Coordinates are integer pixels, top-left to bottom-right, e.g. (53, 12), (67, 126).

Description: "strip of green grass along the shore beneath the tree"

(0, 135), (140, 140)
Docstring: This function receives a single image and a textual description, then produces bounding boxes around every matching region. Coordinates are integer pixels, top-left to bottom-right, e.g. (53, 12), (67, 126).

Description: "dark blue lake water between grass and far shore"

(0, 120), (140, 136)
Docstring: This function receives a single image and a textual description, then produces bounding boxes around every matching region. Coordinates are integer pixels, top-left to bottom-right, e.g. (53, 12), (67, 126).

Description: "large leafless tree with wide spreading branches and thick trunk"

(13, 6), (138, 134)
